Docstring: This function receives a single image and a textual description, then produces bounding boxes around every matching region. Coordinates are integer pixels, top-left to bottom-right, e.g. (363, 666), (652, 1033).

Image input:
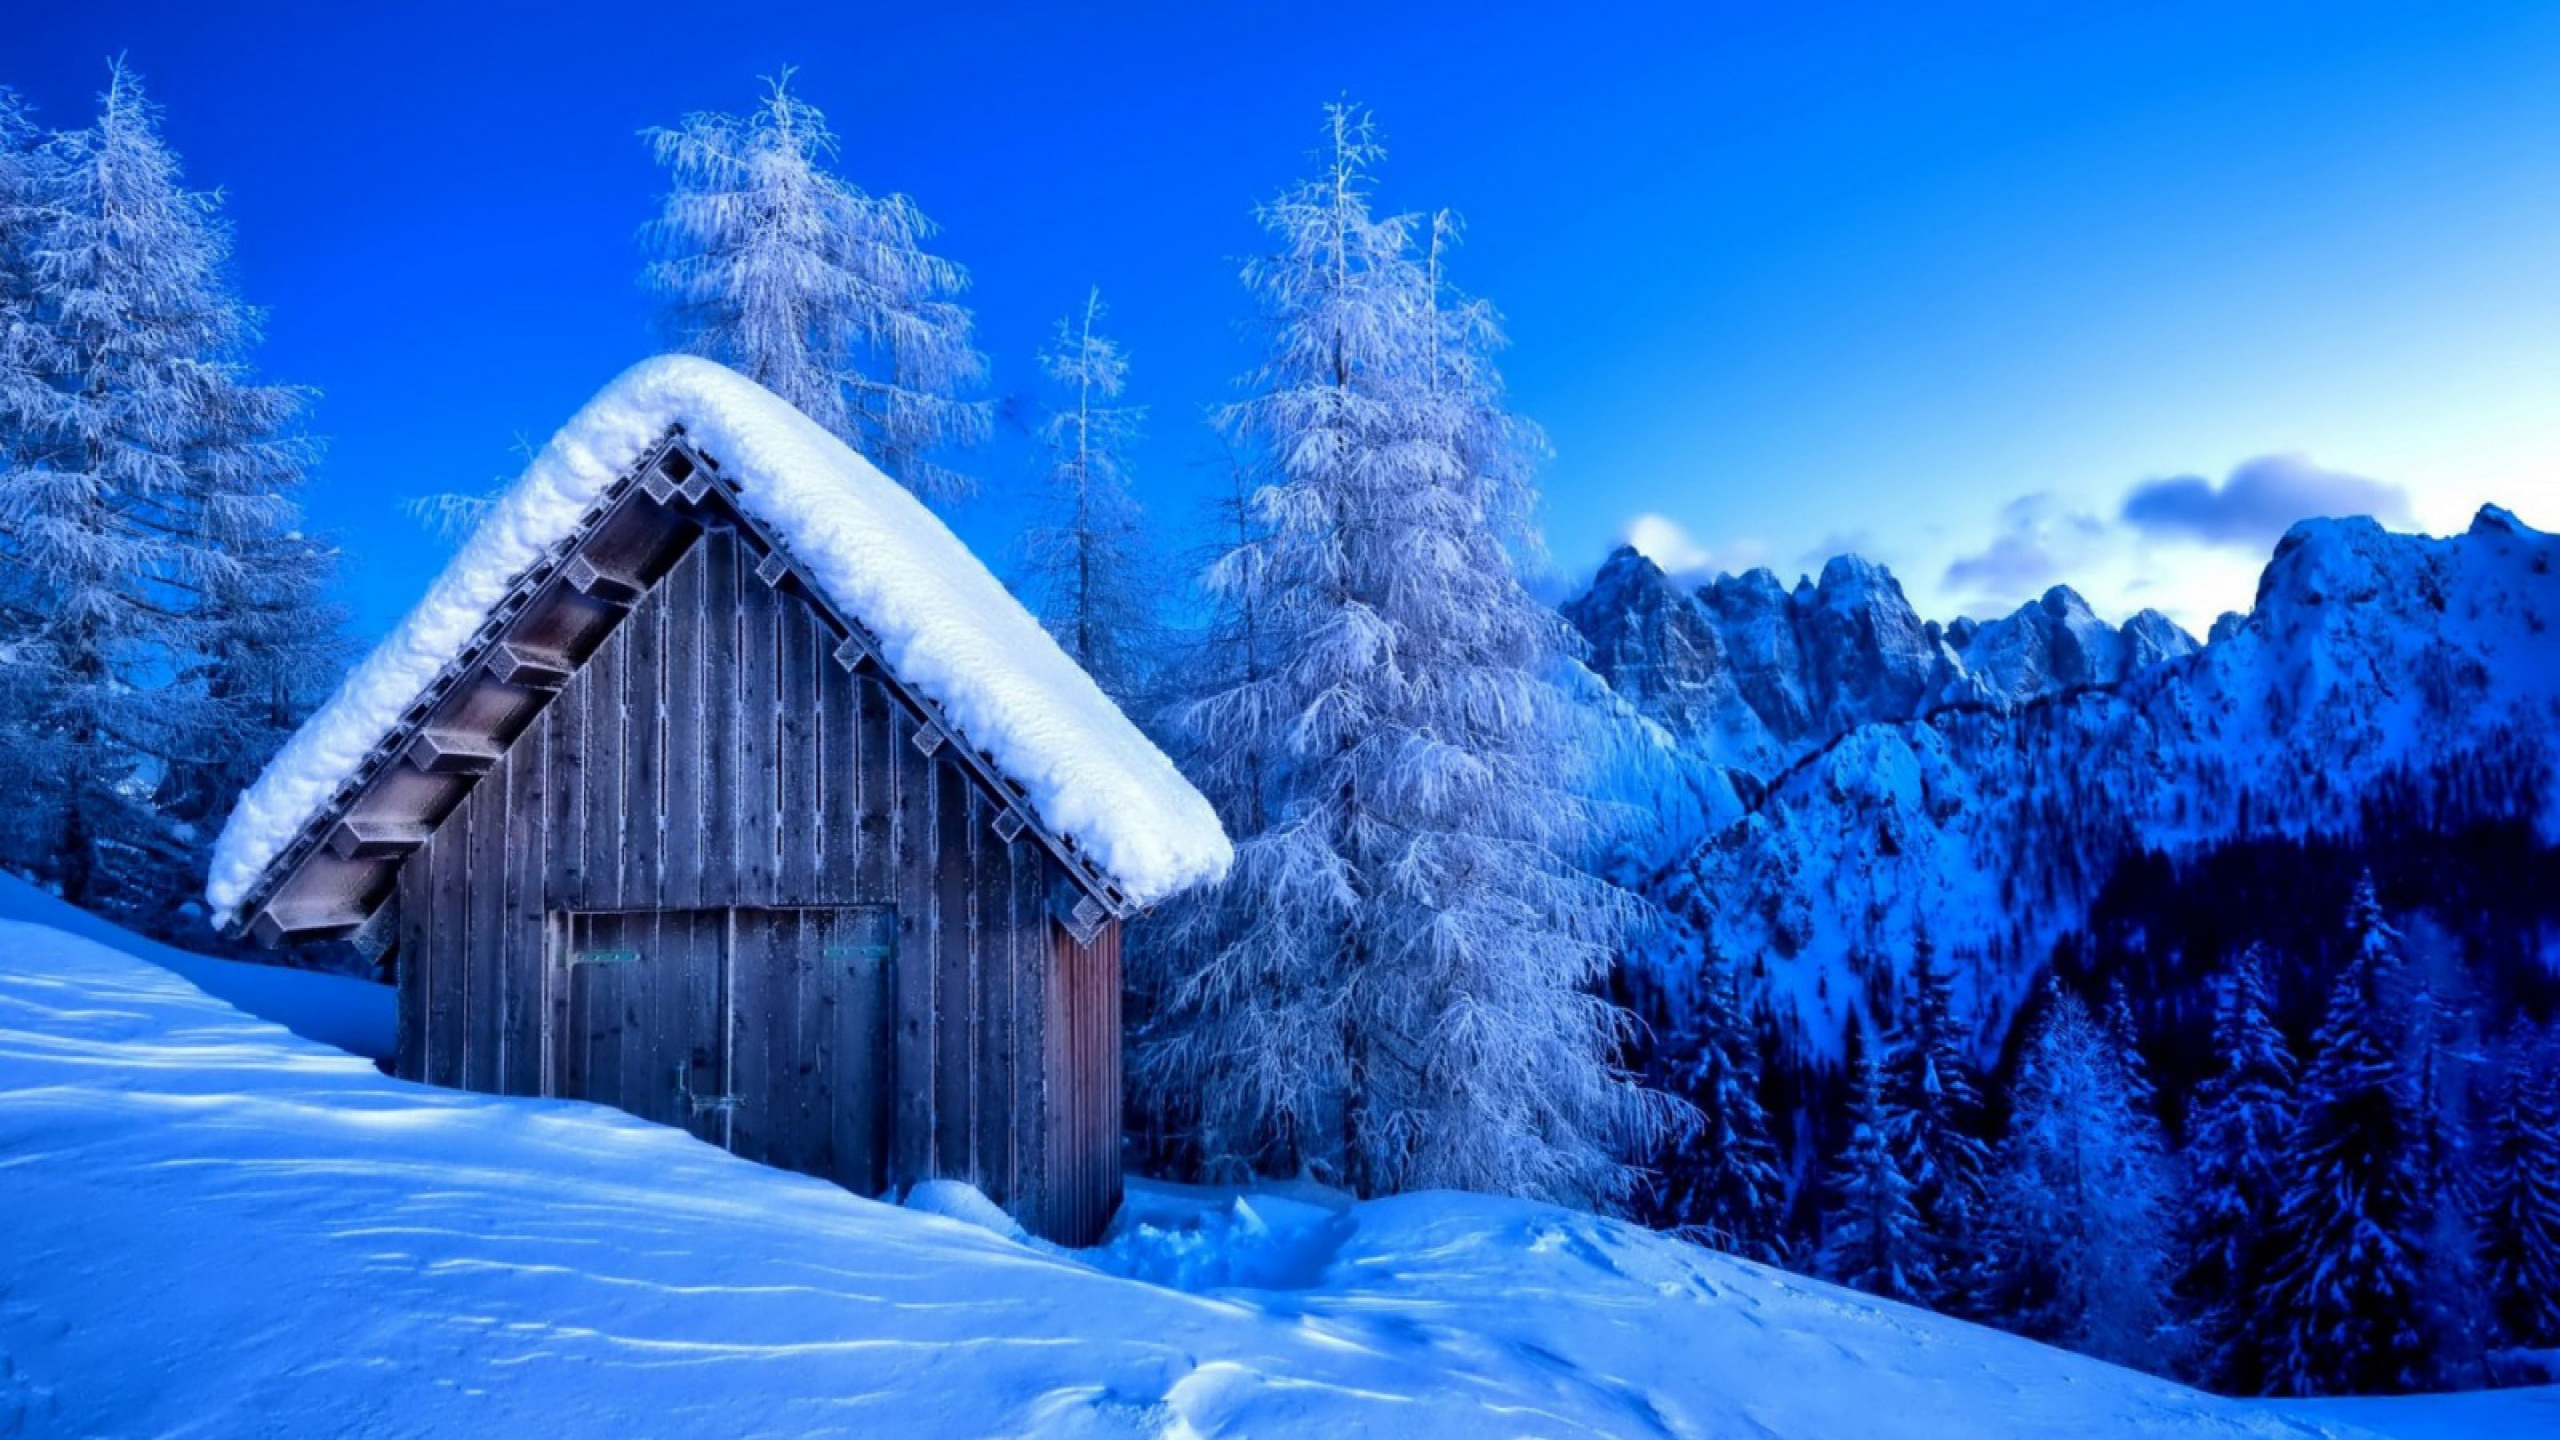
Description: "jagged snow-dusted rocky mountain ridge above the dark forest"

(1567, 507), (2560, 1056)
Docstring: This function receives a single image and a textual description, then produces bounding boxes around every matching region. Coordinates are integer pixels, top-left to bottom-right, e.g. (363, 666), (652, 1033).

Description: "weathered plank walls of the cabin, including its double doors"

(399, 528), (1119, 1240)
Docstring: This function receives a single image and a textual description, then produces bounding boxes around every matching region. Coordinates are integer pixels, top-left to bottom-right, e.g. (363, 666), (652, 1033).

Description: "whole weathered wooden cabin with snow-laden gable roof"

(212, 361), (1226, 1243)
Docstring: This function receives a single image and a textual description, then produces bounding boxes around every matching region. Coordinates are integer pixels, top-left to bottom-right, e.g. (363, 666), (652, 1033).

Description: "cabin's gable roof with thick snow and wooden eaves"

(205, 356), (1231, 935)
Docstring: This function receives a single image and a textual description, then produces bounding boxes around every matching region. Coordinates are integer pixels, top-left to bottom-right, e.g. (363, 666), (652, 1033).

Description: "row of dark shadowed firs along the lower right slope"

(1649, 876), (2560, 1394)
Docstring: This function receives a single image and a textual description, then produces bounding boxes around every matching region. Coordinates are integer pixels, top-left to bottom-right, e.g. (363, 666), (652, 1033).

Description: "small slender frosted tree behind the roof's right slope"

(1024, 290), (1162, 707)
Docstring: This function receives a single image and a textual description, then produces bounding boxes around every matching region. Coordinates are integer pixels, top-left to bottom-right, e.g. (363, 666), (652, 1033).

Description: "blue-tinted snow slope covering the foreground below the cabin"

(0, 922), (2555, 1440)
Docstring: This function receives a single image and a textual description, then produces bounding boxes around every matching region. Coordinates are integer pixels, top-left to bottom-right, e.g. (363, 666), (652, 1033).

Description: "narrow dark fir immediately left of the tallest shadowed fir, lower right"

(2179, 948), (2294, 1394)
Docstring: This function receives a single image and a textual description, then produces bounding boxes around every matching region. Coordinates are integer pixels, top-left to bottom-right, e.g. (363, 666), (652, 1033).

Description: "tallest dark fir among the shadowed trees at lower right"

(2255, 876), (2432, 1394)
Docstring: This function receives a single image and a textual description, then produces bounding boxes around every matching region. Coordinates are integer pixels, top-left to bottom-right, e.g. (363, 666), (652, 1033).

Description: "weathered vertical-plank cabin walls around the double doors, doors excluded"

(399, 528), (1119, 1240)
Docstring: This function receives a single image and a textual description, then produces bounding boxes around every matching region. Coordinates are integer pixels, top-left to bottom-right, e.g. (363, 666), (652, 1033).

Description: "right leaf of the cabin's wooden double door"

(730, 907), (899, 1194)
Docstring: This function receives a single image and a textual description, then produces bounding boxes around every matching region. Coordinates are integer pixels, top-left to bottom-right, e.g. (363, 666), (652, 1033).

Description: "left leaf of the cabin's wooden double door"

(553, 910), (735, 1145)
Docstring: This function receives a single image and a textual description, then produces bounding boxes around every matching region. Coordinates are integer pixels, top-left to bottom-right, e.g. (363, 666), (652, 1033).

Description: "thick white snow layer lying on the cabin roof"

(205, 356), (1231, 925)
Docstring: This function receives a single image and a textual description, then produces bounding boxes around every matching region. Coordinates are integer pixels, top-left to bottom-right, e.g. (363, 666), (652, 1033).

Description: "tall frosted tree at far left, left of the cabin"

(0, 64), (333, 930)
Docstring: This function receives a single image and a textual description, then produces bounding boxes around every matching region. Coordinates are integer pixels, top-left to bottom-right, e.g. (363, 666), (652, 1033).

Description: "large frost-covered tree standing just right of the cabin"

(1155, 105), (1659, 1202)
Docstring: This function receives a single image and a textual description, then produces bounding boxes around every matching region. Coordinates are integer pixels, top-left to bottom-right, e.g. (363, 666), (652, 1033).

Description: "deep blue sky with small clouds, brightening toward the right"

(0, 0), (2560, 633)
